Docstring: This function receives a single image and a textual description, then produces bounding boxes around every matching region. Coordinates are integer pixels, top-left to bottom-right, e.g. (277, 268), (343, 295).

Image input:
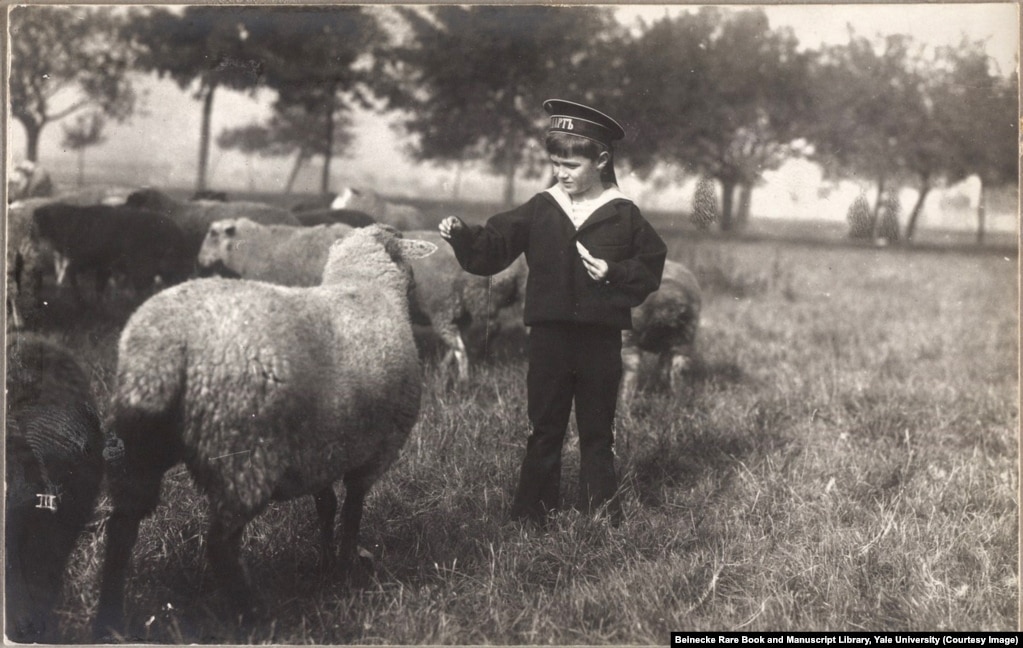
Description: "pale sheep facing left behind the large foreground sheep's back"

(197, 218), (352, 286)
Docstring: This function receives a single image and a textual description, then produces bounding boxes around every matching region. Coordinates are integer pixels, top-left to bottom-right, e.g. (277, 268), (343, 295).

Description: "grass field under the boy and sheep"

(6, 197), (1020, 645)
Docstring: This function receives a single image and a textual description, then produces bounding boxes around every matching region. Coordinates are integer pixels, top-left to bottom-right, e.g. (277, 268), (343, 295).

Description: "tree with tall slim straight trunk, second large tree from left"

(125, 5), (264, 191)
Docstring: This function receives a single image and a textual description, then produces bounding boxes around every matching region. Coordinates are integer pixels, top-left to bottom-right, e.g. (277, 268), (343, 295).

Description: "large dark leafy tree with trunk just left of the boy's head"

(376, 5), (614, 204)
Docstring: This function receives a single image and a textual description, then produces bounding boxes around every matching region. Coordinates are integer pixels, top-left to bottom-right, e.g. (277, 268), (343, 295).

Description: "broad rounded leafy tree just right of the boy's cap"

(608, 7), (811, 230)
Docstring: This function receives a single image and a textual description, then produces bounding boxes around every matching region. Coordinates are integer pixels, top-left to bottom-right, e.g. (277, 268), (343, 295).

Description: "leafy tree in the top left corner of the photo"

(9, 6), (135, 162)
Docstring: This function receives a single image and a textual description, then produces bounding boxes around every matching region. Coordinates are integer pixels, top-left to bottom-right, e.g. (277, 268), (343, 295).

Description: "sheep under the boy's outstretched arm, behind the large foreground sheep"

(408, 230), (528, 381)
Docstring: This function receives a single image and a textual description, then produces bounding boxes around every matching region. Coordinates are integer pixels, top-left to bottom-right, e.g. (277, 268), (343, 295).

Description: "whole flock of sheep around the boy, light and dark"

(6, 178), (700, 641)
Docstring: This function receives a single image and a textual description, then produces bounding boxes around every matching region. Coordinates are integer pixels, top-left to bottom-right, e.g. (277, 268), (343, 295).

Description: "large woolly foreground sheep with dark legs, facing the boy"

(95, 225), (436, 635)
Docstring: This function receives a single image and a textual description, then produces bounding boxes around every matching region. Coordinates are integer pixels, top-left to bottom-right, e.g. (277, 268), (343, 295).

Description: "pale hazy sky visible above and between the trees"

(10, 2), (1019, 227)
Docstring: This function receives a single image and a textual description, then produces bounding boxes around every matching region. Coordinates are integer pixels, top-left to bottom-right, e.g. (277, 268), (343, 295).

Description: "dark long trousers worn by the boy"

(512, 323), (622, 522)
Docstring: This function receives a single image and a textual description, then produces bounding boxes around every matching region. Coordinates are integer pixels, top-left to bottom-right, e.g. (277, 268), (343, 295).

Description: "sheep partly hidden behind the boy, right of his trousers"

(622, 259), (701, 404)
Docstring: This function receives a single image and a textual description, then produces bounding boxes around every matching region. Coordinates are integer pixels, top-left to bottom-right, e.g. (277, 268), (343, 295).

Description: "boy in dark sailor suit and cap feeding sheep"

(440, 99), (667, 524)
